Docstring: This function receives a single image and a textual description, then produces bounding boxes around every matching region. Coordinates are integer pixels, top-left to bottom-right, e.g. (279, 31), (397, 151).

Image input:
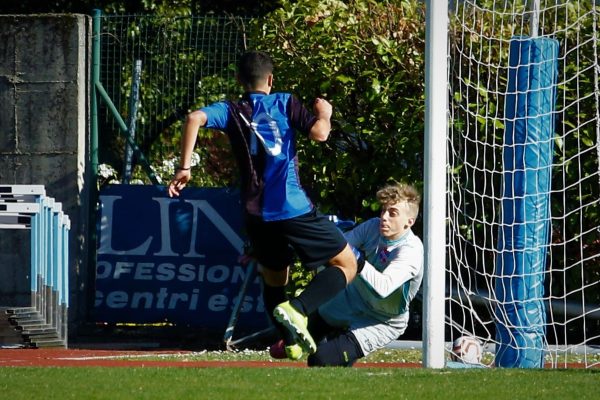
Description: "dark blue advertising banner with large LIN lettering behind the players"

(94, 185), (269, 331)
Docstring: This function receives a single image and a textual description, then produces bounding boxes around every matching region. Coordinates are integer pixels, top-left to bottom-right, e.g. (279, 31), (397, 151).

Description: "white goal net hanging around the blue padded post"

(445, 0), (600, 368)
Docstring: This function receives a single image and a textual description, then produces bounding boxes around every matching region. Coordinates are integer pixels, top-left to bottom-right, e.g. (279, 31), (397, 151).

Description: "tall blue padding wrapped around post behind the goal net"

(495, 37), (558, 368)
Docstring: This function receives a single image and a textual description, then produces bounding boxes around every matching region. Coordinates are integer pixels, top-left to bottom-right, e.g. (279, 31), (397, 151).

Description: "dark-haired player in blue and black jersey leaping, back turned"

(169, 51), (357, 359)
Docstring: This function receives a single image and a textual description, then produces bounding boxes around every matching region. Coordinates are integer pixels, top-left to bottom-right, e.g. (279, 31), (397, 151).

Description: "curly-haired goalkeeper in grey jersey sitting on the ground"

(271, 184), (423, 366)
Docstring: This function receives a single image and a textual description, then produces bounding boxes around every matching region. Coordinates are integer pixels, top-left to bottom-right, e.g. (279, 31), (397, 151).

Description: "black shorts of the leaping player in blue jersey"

(246, 209), (347, 271)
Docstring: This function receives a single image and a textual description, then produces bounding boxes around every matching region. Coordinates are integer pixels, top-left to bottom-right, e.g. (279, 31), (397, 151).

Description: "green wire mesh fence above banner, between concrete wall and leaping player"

(94, 15), (251, 181)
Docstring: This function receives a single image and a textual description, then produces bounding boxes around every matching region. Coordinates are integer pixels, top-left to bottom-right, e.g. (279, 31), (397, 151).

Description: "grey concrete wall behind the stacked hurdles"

(0, 14), (91, 332)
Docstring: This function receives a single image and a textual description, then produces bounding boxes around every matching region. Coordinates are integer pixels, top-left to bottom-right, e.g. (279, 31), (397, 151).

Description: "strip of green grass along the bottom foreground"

(0, 367), (600, 400)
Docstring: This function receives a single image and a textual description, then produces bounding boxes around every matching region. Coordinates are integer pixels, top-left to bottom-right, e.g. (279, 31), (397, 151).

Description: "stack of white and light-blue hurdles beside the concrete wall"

(0, 185), (70, 347)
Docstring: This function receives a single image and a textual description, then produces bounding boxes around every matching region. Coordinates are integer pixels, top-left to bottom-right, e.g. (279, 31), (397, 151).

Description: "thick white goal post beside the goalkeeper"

(423, 0), (448, 368)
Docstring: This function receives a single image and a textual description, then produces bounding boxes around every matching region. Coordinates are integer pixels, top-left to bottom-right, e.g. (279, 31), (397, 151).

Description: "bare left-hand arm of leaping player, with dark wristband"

(169, 110), (206, 197)
